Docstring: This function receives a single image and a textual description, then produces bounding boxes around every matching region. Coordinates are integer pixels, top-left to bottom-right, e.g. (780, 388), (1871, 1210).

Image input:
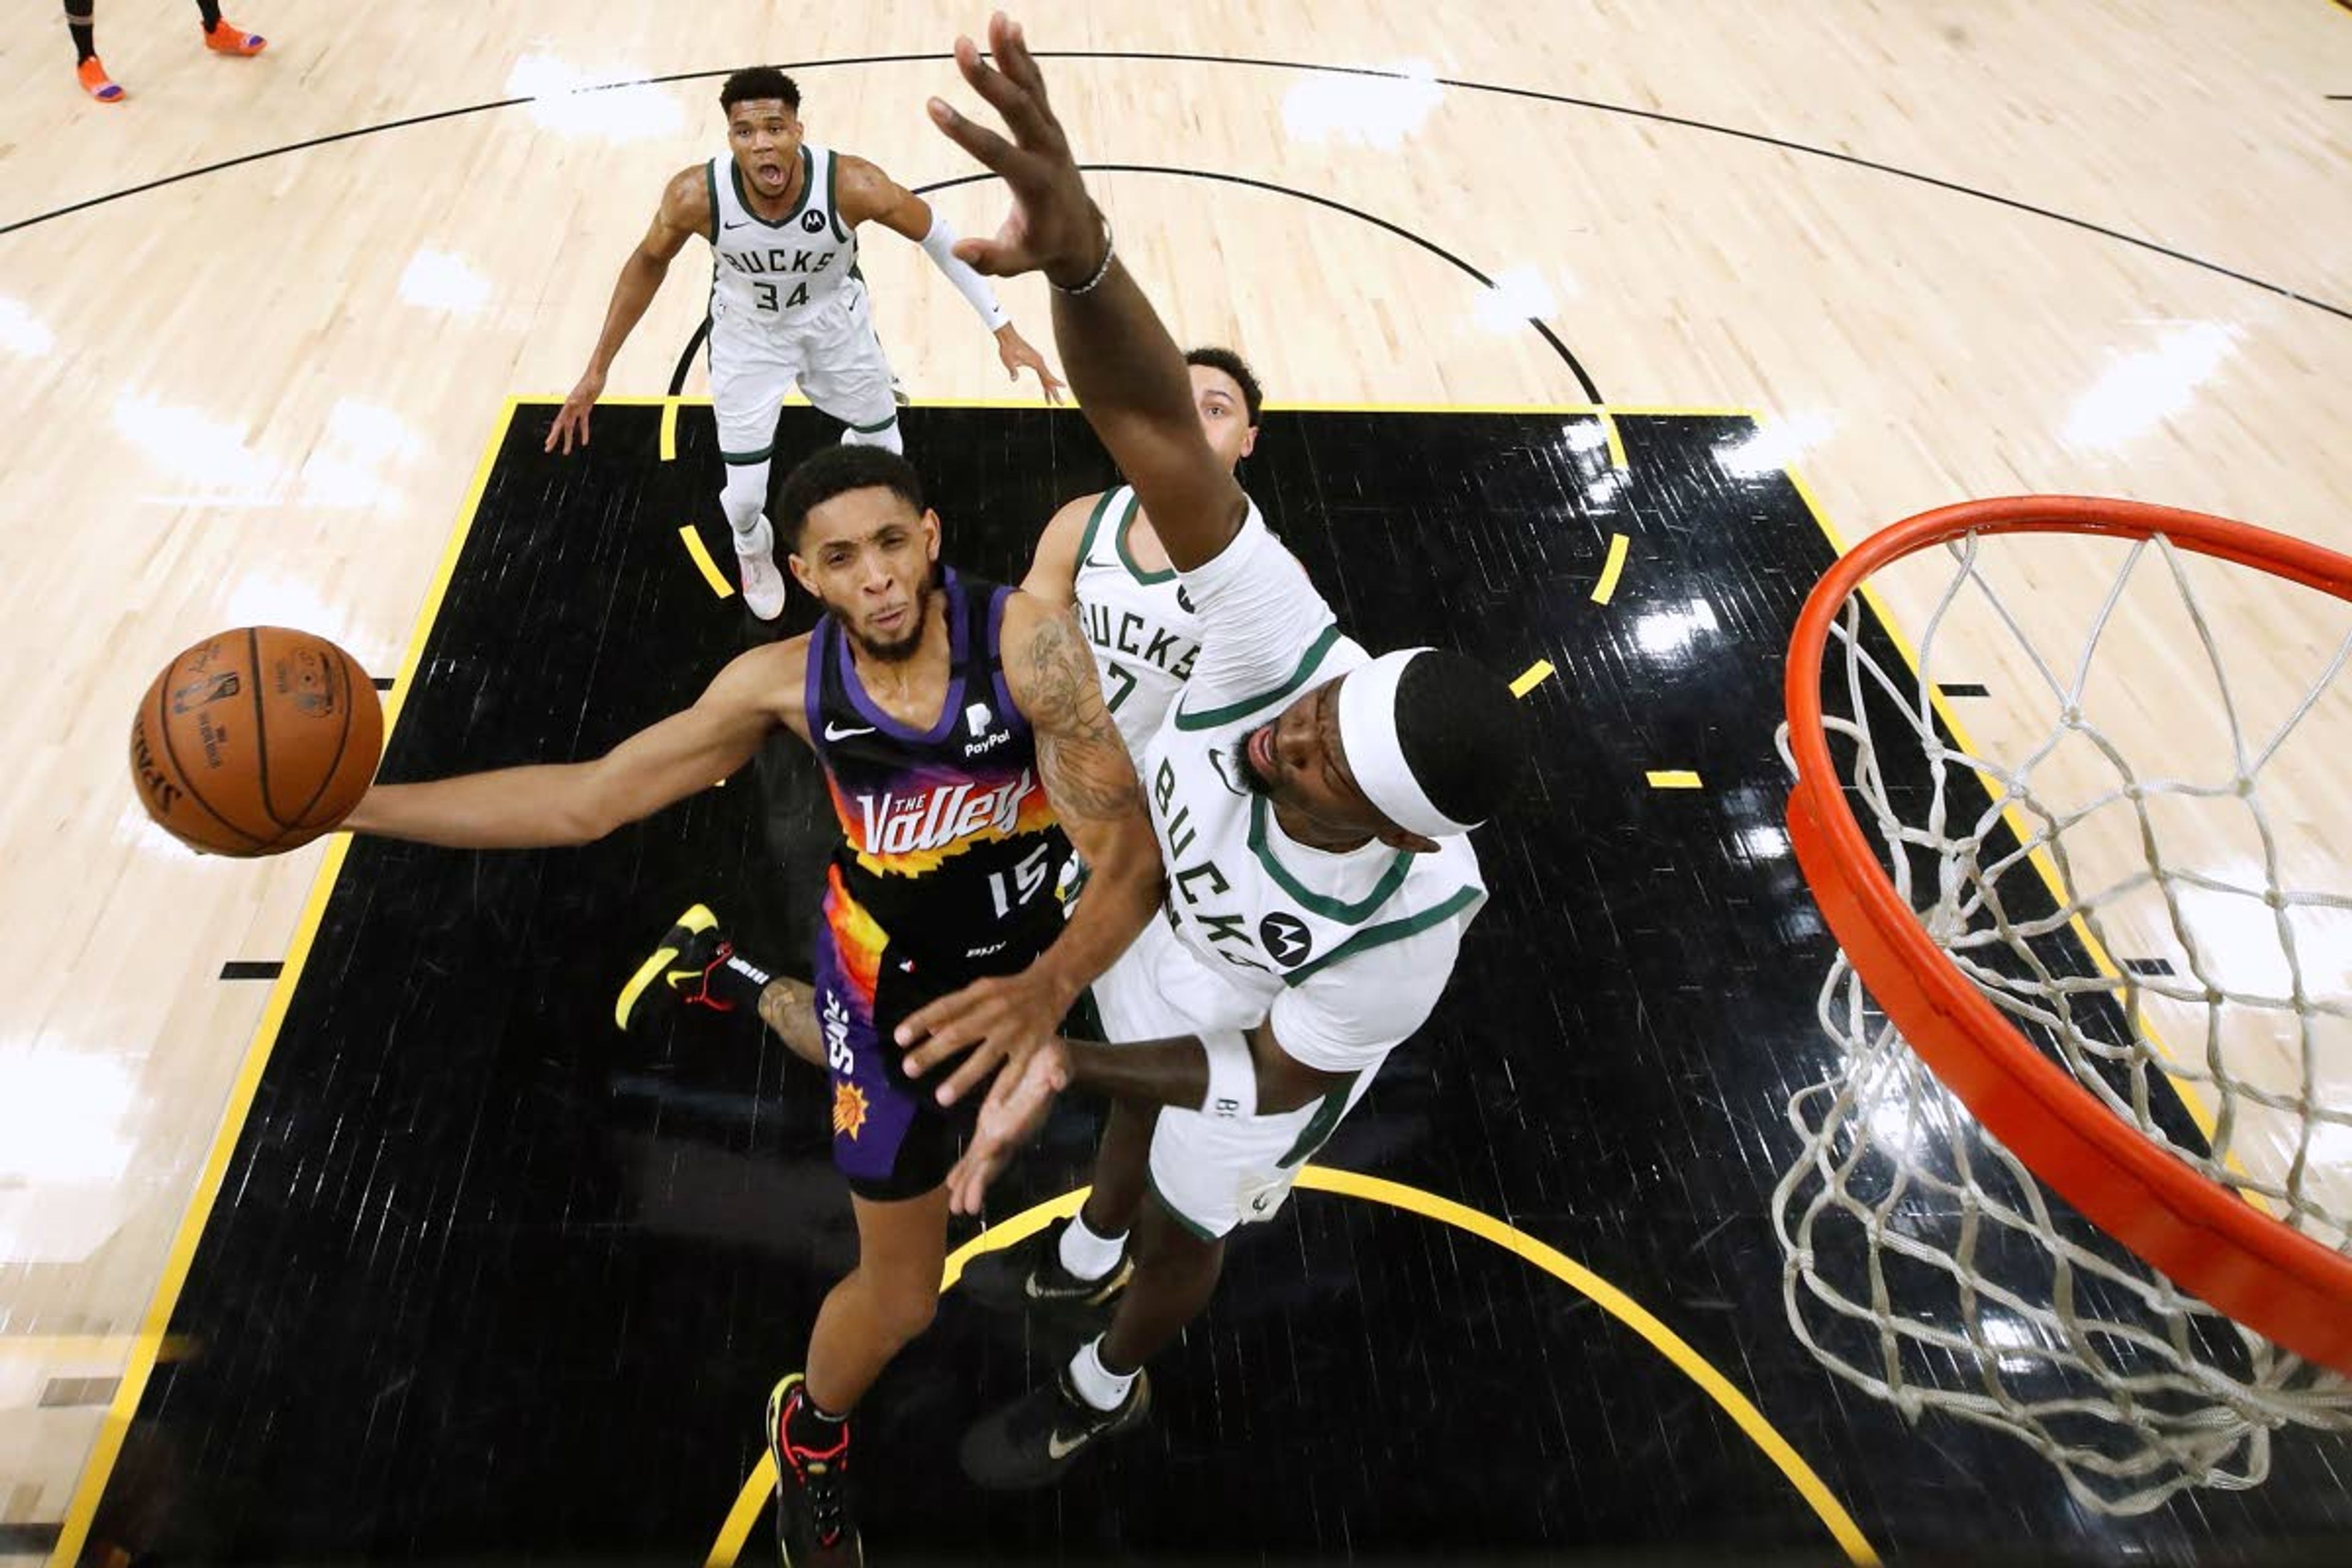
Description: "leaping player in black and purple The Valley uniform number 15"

(348, 447), (1162, 1563)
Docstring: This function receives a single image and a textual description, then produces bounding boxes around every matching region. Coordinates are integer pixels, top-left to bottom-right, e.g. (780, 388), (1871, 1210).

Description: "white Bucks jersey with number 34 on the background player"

(703, 141), (859, 329)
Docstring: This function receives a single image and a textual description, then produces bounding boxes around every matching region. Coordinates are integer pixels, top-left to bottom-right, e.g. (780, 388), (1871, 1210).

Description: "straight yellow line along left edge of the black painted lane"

(50, 398), (520, 1568)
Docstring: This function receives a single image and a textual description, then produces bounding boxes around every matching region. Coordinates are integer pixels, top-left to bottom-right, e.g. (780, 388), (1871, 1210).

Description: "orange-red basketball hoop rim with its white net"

(1773, 496), (2352, 1512)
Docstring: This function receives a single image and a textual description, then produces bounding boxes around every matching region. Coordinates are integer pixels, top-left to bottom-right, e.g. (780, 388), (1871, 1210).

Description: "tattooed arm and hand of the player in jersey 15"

(899, 592), (1167, 1105)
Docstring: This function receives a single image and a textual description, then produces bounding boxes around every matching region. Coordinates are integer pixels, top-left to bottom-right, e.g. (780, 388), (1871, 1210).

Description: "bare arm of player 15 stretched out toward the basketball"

(344, 639), (807, 849)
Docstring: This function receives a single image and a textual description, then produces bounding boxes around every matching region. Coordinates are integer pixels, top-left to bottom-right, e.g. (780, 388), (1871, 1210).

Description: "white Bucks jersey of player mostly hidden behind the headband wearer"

(1075, 484), (1199, 757)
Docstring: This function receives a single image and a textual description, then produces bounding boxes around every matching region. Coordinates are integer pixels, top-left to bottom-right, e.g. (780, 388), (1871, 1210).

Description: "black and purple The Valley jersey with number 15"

(807, 569), (1068, 973)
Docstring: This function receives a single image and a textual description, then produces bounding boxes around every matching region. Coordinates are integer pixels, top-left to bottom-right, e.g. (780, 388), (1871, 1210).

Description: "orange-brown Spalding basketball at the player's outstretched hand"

(132, 625), (383, 856)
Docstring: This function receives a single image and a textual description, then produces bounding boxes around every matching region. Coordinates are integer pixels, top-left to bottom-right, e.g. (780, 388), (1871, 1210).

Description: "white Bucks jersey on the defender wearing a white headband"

(1143, 628), (1487, 1025)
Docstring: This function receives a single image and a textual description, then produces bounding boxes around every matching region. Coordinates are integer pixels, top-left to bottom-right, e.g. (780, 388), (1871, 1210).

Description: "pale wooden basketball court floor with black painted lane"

(0, 0), (2352, 1563)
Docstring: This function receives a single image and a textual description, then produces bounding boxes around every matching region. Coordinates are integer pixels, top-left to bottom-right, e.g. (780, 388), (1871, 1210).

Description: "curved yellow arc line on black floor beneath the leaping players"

(703, 1166), (1879, 1568)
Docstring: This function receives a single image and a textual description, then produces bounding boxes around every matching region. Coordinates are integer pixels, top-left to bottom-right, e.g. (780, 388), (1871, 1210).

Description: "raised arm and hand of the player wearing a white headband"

(932, 14), (1249, 571)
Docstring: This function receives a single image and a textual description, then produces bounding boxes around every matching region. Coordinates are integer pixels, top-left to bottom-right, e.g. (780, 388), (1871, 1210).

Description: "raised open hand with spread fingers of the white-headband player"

(929, 12), (1103, 289)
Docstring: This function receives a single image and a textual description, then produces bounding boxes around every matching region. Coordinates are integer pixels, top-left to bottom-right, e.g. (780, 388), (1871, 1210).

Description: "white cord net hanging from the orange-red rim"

(1773, 536), (2352, 1514)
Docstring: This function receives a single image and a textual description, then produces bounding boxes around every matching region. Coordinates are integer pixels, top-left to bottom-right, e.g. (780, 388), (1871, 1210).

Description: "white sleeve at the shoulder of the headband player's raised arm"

(1183, 501), (1338, 712)
